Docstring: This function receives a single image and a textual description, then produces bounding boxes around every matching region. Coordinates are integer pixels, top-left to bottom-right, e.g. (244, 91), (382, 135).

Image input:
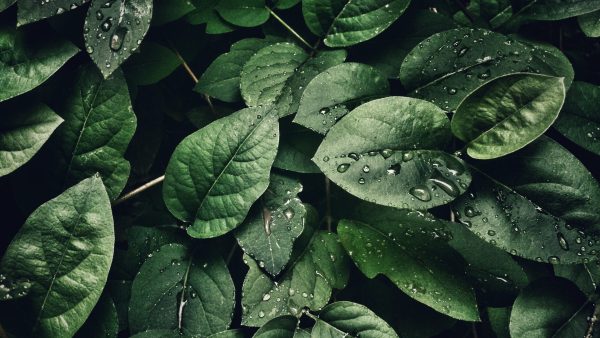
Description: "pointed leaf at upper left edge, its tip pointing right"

(0, 21), (79, 102)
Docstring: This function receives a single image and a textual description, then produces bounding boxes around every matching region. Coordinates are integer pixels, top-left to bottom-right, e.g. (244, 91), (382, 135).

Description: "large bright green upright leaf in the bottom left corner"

(0, 176), (115, 337)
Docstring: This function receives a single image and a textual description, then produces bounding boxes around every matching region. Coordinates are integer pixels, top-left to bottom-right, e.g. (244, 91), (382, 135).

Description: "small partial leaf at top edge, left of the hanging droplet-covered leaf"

(17, 0), (90, 26)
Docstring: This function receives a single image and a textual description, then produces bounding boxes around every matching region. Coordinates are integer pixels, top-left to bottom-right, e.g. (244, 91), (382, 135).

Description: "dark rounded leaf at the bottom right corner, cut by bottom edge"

(510, 278), (592, 338)
